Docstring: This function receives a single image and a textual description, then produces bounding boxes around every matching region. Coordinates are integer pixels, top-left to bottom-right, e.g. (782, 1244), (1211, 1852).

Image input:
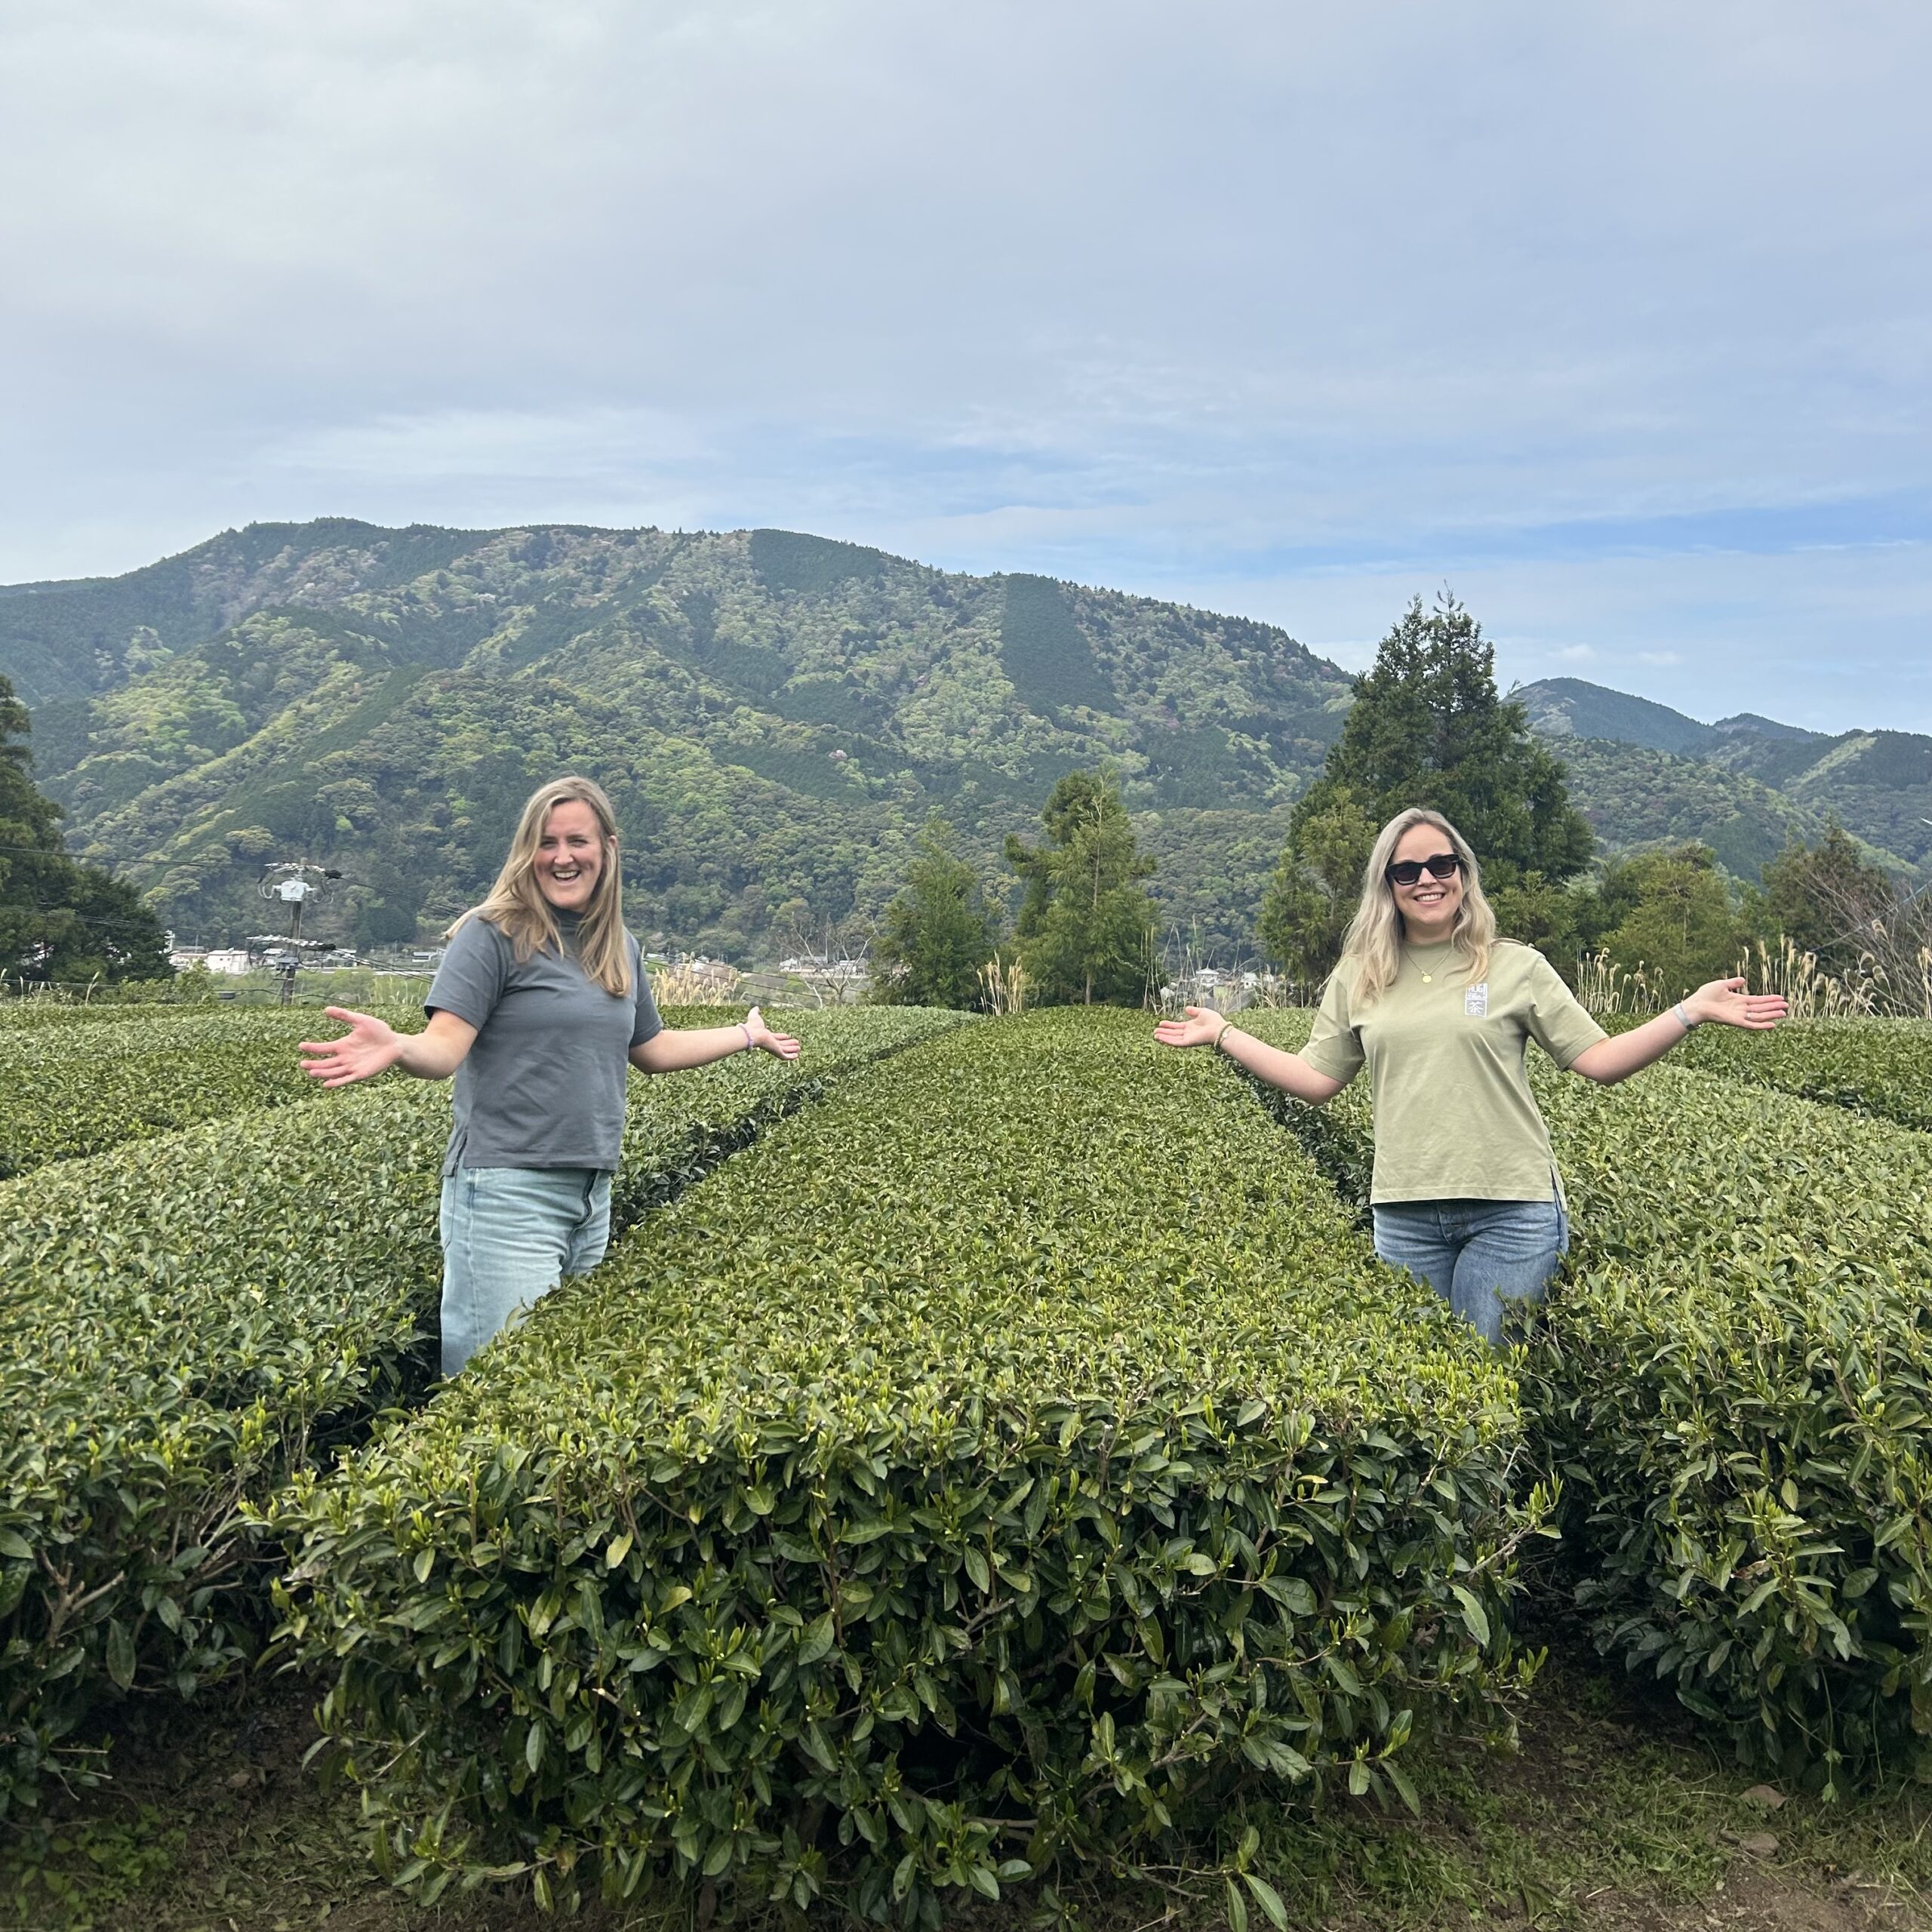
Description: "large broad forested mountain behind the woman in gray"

(0, 520), (1350, 956)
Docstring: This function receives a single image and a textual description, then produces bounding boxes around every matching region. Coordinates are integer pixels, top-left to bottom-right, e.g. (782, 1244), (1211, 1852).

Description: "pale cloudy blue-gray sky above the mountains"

(0, 0), (1932, 731)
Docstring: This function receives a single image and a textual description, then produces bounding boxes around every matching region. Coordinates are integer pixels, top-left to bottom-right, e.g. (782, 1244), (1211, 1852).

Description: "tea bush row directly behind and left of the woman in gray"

(0, 1008), (960, 1814)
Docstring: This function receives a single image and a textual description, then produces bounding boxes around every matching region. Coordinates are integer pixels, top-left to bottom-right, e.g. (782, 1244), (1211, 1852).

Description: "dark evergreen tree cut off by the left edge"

(0, 676), (170, 983)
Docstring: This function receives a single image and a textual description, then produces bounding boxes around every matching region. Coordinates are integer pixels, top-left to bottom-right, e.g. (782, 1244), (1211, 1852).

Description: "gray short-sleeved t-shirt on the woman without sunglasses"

(423, 912), (665, 1174)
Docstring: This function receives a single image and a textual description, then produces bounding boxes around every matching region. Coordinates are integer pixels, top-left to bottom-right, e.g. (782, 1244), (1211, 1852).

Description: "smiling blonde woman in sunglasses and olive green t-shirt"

(1155, 810), (1785, 1343)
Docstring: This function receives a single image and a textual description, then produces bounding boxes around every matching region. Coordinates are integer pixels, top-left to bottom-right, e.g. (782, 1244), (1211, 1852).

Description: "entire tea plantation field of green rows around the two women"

(0, 1008), (1932, 1932)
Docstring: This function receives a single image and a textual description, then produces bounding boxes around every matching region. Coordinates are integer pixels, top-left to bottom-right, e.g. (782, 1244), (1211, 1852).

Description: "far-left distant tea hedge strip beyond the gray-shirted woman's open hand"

(0, 1007), (368, 1180)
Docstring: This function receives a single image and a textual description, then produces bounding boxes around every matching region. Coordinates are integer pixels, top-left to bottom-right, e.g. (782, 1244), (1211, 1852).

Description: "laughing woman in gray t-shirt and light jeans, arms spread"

(301, 779), (798, 1376)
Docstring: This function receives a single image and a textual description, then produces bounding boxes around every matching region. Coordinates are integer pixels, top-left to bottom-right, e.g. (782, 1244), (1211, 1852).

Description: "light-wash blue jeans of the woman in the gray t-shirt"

(442, 1167), (611, 1376)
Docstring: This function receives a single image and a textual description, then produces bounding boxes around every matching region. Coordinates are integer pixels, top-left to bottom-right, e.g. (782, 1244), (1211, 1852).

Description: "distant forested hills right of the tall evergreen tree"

(1509, 678), (1932, 879)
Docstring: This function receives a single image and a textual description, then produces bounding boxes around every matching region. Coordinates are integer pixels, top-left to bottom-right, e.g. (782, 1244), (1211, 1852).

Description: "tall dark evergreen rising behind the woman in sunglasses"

(1260, 593), (1596, 981)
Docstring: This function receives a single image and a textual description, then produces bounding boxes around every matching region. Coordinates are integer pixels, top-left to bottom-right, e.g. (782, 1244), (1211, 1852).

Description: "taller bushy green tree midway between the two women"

(1007, 771), (1155, 1007)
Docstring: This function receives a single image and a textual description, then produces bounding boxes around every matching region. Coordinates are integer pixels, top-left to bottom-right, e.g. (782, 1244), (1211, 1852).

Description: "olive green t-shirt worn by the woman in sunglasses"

(1300, 939), (1604, 1201)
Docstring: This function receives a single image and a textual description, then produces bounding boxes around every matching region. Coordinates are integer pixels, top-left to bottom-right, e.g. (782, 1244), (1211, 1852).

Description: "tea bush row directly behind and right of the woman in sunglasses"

(1254, 1017), (1932, 1780)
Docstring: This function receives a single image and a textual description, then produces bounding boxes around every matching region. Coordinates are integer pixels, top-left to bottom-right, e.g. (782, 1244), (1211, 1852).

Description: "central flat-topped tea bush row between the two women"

(280, 1012), (1522, 1924)
